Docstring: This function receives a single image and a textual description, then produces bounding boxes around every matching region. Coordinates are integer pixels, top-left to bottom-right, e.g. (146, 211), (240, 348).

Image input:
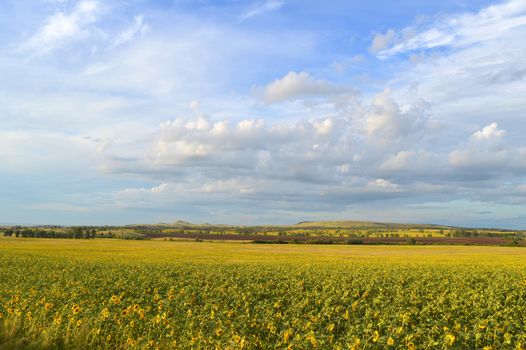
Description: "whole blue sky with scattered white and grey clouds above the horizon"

(0, 0), (526, 229)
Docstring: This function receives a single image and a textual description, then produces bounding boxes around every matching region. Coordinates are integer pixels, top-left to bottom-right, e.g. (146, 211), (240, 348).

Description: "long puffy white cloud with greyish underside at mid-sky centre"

(148, 115), (354, 177)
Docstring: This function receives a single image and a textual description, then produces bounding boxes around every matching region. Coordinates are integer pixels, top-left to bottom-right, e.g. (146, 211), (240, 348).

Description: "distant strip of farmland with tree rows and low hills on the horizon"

(0, 221), (526, 245)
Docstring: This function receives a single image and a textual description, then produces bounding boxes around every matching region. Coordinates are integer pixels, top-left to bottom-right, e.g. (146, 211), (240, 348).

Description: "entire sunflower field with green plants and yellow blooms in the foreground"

(0, 238), (526, 349)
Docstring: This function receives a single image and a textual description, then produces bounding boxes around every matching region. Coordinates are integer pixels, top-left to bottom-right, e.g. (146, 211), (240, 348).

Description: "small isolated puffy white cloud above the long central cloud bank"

(263, 72), (346, 103)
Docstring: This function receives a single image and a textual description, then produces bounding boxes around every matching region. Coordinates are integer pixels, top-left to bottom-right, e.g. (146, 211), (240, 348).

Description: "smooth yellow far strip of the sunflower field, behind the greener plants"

(0, 237), (526, 268)
